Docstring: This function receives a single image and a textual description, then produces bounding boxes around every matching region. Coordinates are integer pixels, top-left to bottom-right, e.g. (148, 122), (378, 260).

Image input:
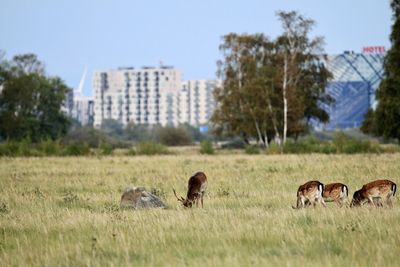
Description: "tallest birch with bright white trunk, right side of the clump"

(277, 11), (333, 143)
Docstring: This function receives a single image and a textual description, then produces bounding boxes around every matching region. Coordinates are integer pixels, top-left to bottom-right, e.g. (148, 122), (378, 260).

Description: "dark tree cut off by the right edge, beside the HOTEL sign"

(361, 0), (400, 141)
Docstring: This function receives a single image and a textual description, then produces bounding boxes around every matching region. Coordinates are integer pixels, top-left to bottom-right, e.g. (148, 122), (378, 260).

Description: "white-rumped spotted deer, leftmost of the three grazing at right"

(292, 181), (326, 209)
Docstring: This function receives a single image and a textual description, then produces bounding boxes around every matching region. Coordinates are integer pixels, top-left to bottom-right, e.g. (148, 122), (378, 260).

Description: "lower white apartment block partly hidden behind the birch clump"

(178, 80), (222, 127)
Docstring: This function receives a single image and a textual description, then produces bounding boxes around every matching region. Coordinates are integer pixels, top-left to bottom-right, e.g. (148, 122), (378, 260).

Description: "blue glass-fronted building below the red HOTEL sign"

(313, 47), (385, 130)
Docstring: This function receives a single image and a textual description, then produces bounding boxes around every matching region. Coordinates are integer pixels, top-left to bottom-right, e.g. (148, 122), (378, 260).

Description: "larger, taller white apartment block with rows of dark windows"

(92, 66), (181, 127)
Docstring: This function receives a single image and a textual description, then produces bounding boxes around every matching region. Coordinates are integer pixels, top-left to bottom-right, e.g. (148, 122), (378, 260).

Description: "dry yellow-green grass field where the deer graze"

(0, 154), (400, 266)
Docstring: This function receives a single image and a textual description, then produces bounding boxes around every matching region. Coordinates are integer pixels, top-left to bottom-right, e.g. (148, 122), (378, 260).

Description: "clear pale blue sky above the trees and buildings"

(0, 0), (393, 96)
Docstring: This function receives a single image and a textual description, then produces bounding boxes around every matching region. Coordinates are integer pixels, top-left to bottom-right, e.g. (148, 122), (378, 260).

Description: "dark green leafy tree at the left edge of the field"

(0, 55), (69, 142)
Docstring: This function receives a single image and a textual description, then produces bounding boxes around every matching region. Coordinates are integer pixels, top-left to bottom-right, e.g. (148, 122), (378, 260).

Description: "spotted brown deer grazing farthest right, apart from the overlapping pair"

(350, 180), (397, 207)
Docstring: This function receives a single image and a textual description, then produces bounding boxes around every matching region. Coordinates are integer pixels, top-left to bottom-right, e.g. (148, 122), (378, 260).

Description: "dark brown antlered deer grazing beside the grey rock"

(173, 172), (207, 208)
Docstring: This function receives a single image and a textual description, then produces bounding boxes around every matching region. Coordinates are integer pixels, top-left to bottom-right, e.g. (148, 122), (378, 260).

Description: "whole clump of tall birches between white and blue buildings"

(212, 12), (332, 147)
